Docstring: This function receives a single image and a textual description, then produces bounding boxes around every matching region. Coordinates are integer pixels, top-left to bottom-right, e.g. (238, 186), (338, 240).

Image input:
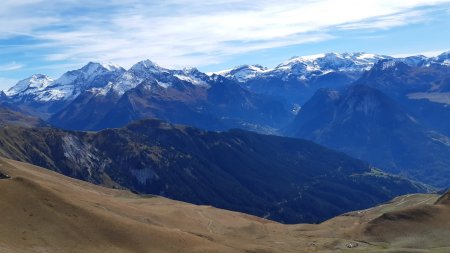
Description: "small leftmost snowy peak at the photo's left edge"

(5, 74), (53, 96)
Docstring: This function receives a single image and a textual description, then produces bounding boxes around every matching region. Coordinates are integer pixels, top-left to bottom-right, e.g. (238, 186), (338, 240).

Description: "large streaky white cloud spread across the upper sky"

(0, 0), (450, 67)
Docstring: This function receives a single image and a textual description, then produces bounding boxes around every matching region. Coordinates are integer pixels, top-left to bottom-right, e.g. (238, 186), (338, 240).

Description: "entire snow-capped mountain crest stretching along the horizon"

(5, 52), (450, 103)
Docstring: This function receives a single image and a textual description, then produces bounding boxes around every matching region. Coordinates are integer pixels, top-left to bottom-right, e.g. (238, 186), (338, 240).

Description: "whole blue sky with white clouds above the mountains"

(0, 0), (450, 89)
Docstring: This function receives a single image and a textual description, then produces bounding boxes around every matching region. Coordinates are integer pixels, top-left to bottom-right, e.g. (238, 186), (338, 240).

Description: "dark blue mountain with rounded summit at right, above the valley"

(286, 85), (450, 187)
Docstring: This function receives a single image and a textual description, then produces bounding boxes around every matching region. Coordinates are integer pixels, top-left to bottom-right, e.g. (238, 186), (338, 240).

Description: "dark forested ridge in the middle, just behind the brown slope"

(0, 120), (426, 223)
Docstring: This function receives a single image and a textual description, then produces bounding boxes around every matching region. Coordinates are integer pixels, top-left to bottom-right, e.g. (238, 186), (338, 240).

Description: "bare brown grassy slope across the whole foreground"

(0, 158), (450, 253)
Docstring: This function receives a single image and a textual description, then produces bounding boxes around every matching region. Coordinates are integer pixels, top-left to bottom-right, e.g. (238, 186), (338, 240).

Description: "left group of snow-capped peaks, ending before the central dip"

(5, 60), (210, 103)
